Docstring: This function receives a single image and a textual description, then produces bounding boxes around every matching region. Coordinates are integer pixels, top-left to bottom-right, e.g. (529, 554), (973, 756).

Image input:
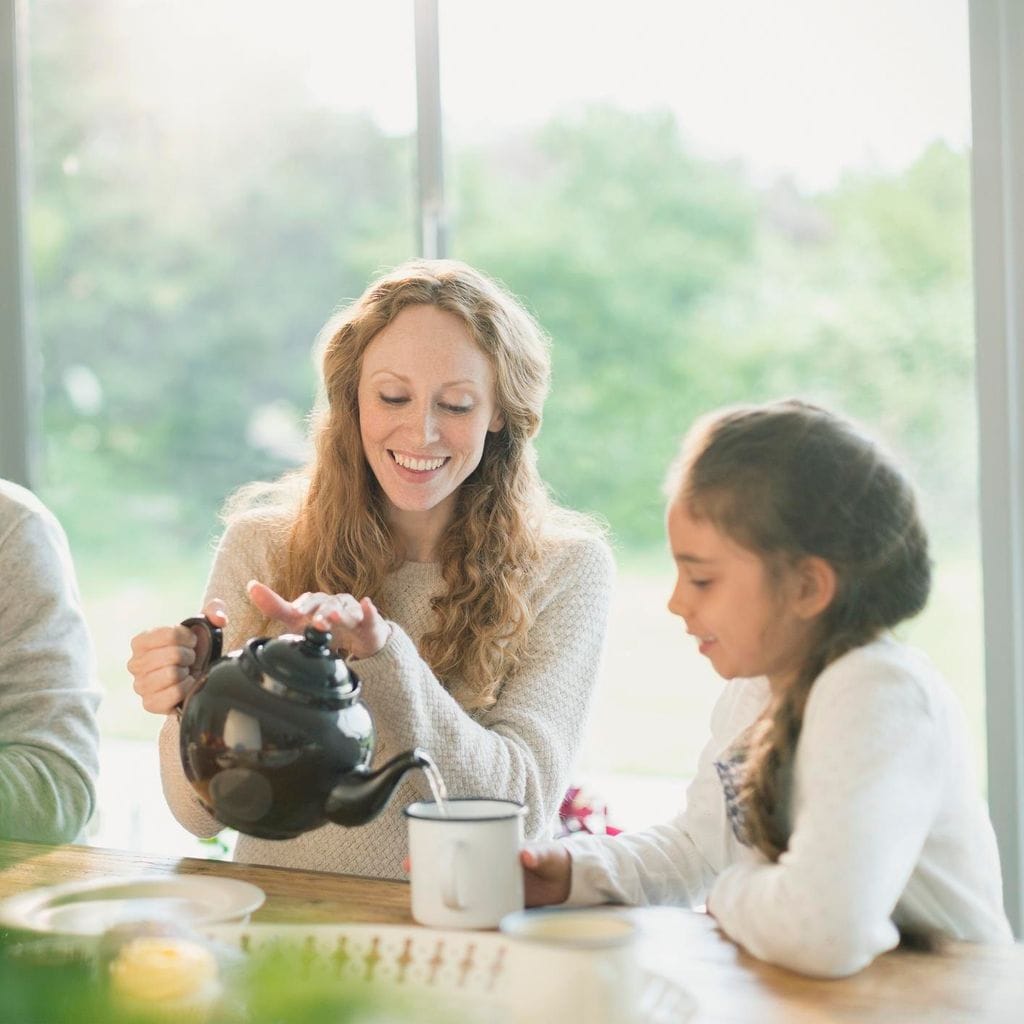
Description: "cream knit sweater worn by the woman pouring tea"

(160, 515), (613, 879)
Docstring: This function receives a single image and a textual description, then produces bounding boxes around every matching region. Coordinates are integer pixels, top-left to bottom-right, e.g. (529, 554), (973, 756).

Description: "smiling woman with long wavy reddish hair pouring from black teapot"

(128, 260), (612, 878)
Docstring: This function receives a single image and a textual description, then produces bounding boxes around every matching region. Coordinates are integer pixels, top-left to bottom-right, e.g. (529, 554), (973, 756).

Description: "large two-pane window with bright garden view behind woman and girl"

(16, 0), (985, 852)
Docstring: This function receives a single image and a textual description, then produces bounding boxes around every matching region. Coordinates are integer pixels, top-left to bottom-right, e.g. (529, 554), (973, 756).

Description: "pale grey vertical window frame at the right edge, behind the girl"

(970, 0), (1024, 937)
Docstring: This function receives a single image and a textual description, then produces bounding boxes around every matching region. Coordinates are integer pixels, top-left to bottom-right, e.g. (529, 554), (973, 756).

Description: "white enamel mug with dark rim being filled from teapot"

(406, 797), (526, 928)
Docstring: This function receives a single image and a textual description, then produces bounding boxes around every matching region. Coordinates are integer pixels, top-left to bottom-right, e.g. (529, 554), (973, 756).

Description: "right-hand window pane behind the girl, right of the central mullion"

(441, 0), (985, 823)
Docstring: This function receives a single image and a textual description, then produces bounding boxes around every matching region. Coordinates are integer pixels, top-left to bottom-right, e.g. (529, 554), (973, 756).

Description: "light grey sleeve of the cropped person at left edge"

(0, 496), (99, 843)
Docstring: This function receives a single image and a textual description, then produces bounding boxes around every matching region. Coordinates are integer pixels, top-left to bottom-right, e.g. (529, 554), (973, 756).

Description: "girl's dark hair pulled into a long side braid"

(672, 399), (931, 860)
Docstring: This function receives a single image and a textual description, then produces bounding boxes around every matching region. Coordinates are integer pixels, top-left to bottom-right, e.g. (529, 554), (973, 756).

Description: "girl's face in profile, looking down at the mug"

(668, 501), (811, 692)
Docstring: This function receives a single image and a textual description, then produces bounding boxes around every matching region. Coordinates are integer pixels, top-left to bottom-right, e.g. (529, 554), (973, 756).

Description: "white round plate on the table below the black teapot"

(0, 874), (266, 935)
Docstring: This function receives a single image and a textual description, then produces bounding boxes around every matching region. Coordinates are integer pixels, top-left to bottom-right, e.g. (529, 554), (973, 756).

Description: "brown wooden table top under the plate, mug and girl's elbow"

(0, 842), (1024, 1024)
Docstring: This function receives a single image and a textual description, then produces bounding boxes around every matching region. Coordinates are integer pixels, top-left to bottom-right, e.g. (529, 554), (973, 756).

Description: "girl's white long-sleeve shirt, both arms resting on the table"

(569, 638), (1012, 977)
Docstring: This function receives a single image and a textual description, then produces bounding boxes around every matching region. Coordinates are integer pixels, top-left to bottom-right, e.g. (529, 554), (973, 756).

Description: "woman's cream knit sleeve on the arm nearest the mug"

(353, 539), (613, 838)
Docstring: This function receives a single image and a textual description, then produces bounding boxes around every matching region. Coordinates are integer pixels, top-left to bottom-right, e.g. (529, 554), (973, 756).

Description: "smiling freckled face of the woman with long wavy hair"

(358, 305), (505, 526)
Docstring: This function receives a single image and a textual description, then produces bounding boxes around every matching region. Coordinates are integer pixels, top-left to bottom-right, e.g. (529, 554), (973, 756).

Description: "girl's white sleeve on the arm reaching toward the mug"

(566, 680), (765, 907)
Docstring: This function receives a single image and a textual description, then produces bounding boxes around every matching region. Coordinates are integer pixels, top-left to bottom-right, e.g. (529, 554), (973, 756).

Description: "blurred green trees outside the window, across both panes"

(30, 0), (976, 566)
